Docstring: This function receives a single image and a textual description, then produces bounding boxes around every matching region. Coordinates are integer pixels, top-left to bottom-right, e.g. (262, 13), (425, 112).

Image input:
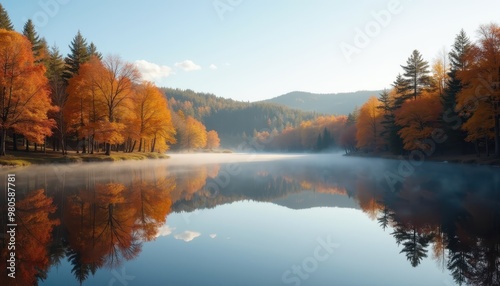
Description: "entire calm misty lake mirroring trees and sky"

(0, 154), (500, 286)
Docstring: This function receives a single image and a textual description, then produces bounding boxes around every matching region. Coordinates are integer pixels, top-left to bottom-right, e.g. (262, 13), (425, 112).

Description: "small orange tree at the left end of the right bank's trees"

(356, 96), (383, 150)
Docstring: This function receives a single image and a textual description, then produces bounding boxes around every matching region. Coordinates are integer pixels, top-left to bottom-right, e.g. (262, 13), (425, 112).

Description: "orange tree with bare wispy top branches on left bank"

(66, 56), (139, 155)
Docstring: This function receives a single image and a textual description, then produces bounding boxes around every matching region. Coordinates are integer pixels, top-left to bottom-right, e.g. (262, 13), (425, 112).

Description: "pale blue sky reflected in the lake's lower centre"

(41, 201), (453, 285)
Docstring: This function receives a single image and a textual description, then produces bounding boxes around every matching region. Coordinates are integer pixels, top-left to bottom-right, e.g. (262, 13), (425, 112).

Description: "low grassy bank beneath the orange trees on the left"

(0, 151), (169, 167)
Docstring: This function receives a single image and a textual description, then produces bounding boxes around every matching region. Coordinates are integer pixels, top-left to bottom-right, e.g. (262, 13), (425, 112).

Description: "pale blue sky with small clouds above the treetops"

(1, 0), (500, 101)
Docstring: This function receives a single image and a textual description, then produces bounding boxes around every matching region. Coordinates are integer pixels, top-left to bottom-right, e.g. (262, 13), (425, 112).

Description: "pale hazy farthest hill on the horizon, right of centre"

(262, 90), (382, 115)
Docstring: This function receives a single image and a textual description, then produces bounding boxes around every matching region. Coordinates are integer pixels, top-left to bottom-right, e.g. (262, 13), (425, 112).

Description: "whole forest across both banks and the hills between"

(0, 1), (500, 158)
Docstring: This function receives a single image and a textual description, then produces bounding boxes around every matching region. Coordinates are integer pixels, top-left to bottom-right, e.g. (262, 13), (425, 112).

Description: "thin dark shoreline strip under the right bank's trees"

(344, 151), (500, 166)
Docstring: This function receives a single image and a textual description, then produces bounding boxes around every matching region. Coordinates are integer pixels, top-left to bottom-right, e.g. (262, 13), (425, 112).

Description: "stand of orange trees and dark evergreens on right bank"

(356, 24), (500, 156)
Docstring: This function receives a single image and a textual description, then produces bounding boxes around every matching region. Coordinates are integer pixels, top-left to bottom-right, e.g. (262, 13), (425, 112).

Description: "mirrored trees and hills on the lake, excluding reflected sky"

(0, 156), (500, 285)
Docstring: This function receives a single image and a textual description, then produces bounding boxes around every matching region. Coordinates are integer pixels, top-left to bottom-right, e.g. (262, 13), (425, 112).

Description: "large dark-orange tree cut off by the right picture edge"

(456, 24), (500, 156)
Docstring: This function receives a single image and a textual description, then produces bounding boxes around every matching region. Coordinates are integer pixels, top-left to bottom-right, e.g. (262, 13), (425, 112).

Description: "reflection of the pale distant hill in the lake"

(271, 191), (359, 209)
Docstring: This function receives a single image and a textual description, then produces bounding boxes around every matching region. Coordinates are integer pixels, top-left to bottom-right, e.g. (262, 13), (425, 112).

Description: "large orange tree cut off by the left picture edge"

(0, 30), (55, 155)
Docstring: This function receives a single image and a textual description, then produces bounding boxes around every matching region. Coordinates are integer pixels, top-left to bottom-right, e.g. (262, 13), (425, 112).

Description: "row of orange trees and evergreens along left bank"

(0, 6), (220, 155)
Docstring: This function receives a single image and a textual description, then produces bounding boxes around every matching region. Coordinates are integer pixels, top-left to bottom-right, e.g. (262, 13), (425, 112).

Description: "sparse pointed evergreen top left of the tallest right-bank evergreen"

(401, 50), (431, 99)
